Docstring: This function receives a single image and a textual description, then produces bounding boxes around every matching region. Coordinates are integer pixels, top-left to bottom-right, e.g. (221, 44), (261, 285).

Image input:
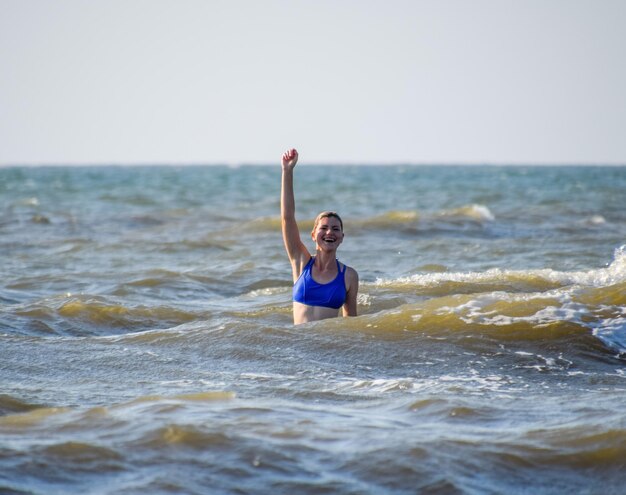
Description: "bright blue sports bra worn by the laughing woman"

(293, 257), (346, 309)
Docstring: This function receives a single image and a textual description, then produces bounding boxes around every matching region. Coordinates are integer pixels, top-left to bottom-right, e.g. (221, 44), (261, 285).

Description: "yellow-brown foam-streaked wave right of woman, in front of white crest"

(356, 282), (626, 342)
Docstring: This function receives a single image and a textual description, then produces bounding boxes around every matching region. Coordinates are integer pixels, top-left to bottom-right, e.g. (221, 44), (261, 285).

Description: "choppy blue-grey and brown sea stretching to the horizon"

(0, 163), (626, 495)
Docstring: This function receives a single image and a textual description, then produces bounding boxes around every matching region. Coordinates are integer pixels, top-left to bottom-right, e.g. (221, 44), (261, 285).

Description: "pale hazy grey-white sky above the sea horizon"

(0, 0), (626, 165)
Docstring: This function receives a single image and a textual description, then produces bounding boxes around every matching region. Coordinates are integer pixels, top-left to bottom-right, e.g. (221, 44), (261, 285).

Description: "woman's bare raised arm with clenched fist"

(280, 149), (311, 281)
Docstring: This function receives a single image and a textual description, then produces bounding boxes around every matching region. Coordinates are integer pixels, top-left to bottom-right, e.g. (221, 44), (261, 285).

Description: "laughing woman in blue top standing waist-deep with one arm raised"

(280, 149), (359, 325)
